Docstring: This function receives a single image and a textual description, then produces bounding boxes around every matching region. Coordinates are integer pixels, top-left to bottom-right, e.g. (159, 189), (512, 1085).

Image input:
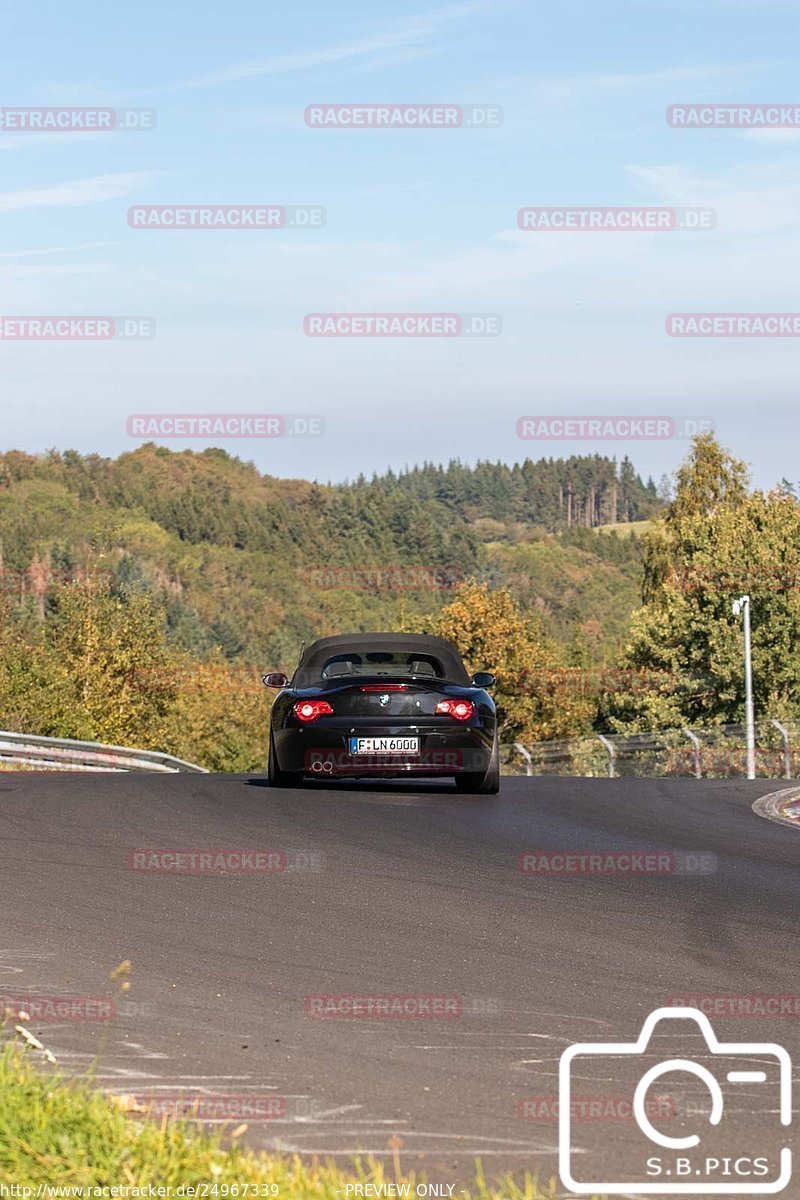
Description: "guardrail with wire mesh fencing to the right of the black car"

(501, 719), (800, 779)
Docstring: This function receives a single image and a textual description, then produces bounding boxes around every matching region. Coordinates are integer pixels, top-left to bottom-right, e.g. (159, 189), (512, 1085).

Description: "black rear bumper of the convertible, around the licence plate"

(273, 724), (494, 779)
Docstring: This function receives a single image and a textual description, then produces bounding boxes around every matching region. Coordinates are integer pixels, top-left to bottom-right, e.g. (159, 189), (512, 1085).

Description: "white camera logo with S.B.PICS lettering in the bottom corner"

(559, 1008), (792, 1195)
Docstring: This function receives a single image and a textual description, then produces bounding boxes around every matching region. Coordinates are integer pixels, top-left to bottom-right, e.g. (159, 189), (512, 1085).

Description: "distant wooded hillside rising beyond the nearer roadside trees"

(0, 445), (660, 667)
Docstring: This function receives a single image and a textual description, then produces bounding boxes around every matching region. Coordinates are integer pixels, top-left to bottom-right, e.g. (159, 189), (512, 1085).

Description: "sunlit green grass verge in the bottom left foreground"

(0, 1030), (555, 1200)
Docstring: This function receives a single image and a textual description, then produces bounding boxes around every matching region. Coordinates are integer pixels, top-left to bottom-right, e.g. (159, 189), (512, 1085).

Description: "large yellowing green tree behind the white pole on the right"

(608, 433), (800, 730)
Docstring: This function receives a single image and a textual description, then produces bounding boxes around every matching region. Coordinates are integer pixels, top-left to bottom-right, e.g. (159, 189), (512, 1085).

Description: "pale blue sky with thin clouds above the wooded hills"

(0, 0), (800, 486)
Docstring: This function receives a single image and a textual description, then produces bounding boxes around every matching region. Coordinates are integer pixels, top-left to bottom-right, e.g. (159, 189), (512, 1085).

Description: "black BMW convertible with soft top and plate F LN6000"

(264, 634), (500, 793)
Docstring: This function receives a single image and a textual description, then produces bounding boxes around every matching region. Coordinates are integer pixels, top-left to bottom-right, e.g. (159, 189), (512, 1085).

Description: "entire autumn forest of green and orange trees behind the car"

(0, 434), (800, 770)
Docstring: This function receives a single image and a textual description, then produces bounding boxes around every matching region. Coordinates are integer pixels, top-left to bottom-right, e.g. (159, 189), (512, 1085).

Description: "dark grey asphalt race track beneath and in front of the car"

(0, 773), (800, 1192)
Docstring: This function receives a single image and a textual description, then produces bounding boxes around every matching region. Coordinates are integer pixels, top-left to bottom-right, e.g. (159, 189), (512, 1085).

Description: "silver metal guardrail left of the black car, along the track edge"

(0, 730), (207, 775)
